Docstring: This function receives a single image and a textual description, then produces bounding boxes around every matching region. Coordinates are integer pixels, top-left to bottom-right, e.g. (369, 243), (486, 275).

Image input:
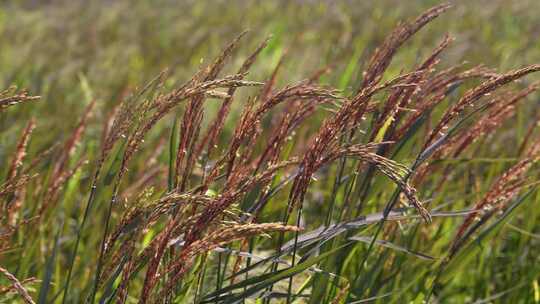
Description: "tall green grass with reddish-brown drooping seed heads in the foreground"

(0, 4), (540, 303)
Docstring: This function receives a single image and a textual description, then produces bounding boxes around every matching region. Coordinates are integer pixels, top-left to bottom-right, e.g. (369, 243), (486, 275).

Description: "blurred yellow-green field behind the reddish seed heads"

(0, 0), (540, 129)
